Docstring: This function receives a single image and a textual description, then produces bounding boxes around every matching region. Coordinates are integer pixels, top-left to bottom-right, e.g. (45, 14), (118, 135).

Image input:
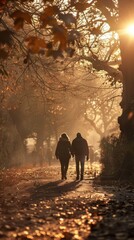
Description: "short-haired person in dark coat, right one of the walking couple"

(72, 133), (89, 180)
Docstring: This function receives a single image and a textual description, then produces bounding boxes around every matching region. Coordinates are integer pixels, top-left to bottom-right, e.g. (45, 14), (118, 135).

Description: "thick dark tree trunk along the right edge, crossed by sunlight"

(118, 0), (134, 176)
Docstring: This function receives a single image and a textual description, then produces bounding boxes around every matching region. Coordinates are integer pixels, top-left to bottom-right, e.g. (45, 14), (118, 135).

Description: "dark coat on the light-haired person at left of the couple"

(55, 137), (71, 160)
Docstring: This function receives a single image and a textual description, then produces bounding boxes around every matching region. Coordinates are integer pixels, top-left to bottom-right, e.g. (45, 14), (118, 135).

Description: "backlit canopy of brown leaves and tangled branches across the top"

(0, 0), (120, 79)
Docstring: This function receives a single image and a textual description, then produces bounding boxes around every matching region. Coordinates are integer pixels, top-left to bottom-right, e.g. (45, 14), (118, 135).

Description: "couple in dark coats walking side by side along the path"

(55, 133), (89, 180)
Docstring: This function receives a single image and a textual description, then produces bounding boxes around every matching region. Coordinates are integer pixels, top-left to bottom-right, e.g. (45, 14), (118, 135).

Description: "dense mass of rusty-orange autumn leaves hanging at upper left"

(0, 0), (84, 58)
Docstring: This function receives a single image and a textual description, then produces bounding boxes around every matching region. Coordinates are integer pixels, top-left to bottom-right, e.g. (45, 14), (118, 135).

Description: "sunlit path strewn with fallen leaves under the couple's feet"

(0, 164), (134, 240)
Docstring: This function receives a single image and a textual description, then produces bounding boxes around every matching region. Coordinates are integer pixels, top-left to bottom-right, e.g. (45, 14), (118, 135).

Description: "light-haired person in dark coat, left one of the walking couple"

(55, 133), (71, 180)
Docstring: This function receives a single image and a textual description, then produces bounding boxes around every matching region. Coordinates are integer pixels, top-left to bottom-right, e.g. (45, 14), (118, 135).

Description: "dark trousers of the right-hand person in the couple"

(75, 156), (85, 179)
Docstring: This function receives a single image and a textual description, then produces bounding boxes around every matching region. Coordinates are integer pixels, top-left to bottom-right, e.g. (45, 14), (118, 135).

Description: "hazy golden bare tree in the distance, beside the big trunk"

(84, 79), (121, 140)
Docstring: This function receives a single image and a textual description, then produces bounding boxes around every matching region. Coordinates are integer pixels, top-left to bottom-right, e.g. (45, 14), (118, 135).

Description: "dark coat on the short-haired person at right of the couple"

(72, 137), (89, 158)
